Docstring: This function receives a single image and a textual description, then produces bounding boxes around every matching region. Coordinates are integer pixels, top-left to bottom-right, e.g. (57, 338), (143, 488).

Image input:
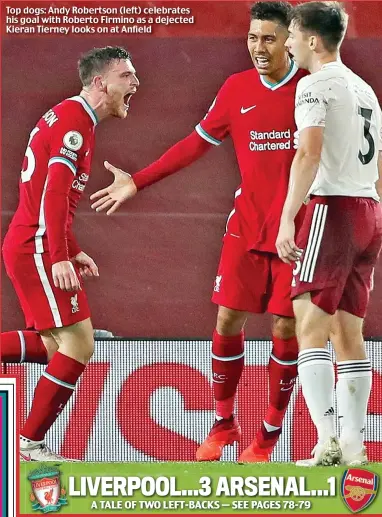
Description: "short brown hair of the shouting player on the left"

(78, 47), (131, 86)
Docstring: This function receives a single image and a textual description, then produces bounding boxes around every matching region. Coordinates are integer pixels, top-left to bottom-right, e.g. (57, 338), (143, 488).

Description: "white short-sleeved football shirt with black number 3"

(295, 61), (382, 200)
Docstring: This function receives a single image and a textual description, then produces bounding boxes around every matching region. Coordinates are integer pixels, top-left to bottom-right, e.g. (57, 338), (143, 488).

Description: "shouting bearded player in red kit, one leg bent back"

(1, 47), (139, 461)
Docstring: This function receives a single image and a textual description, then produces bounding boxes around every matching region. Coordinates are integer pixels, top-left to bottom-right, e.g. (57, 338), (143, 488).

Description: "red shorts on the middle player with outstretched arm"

(212, 234), (294, 318)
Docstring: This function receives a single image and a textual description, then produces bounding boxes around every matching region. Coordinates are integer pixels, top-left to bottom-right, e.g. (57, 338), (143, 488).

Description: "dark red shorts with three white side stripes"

(292, 196), (382, 318)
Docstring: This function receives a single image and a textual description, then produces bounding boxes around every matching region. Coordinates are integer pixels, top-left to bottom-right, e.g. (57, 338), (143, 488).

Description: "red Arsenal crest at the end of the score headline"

(341, 469), (379, 513)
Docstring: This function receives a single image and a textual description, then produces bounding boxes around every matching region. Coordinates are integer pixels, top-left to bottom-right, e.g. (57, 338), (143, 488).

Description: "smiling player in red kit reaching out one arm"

(91, 2), (306, 462)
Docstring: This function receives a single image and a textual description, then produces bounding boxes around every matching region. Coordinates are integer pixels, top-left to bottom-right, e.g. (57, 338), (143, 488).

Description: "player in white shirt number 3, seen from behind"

(276, 2), (382, 466)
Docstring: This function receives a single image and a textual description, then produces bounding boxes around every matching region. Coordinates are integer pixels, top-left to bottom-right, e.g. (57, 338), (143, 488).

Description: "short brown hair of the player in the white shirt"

(291, 2), (348, 52)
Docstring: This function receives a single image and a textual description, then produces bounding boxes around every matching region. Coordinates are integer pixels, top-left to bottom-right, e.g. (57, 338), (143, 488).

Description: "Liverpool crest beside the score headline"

(28, 466), (68, 513)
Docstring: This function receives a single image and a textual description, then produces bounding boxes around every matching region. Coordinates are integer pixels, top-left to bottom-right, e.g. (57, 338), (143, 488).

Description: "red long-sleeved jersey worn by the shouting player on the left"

(3, 96), (97, 263)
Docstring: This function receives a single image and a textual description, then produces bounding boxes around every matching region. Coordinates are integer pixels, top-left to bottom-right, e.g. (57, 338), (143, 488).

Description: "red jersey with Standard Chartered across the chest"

(195, 62), (306, 253)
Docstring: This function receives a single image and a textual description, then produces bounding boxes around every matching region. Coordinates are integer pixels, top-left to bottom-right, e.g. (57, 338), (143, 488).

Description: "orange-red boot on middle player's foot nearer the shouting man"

(196, 415), (241, 461)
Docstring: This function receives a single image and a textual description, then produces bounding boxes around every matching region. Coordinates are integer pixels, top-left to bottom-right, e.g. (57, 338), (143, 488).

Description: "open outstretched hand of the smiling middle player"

(90, 162), (138, 215)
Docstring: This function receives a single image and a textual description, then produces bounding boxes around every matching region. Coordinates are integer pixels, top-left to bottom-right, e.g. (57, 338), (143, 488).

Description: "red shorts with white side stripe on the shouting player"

(3, 251), (90, 330)
